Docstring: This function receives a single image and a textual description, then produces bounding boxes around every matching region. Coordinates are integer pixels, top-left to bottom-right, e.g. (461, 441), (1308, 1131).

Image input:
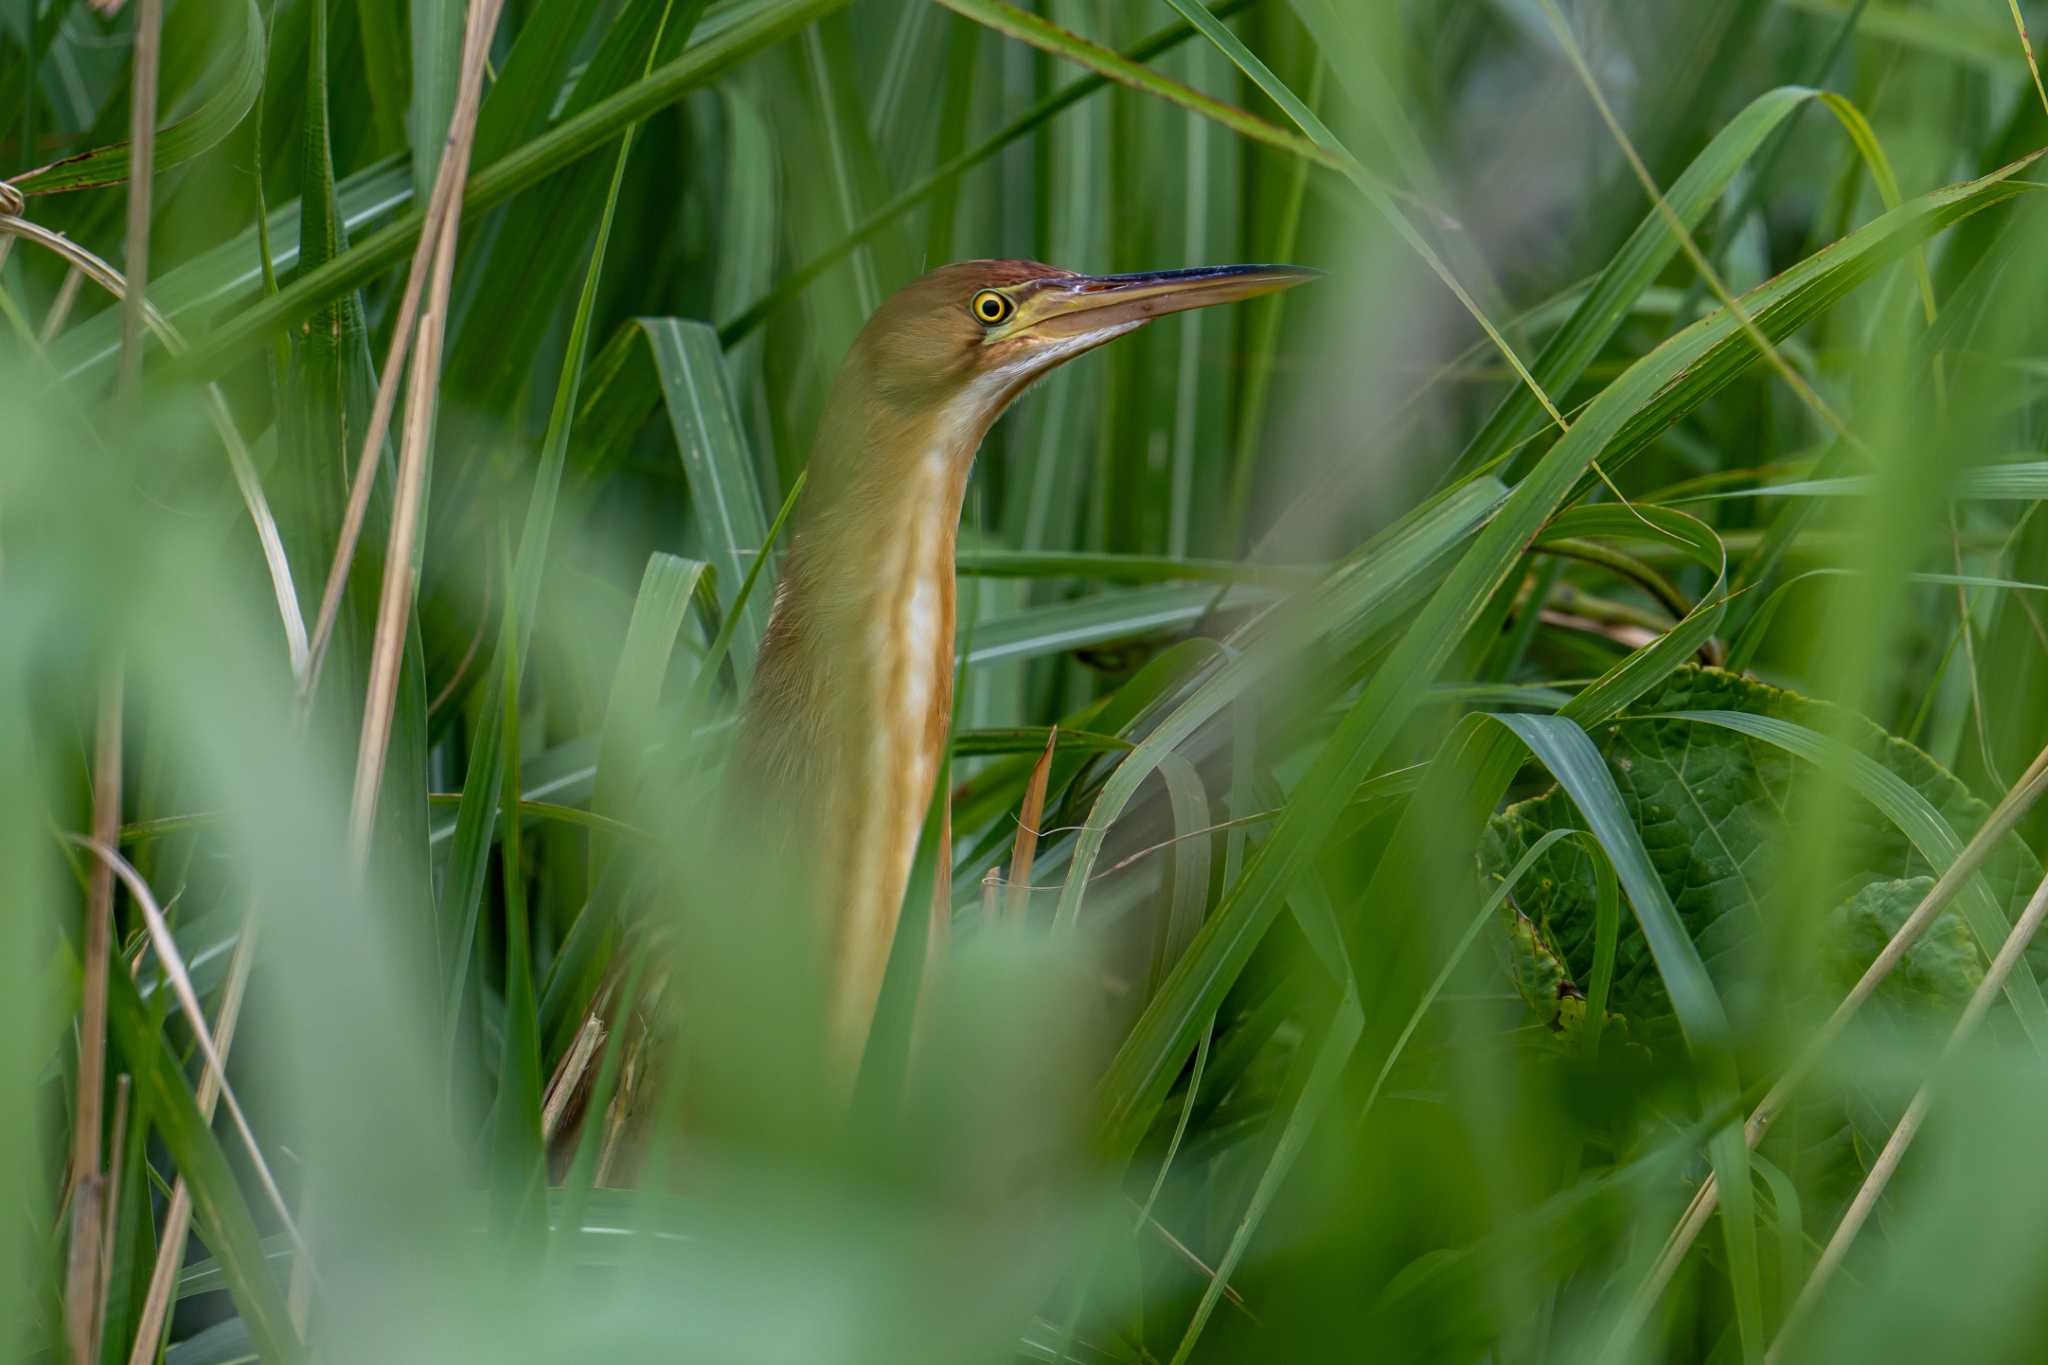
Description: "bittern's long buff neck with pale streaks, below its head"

(737, 377), (993, 1076)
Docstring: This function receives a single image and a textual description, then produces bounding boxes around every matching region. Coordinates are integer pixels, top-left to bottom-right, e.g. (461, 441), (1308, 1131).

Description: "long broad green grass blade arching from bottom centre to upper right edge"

(1089, 158), (2034, 1178)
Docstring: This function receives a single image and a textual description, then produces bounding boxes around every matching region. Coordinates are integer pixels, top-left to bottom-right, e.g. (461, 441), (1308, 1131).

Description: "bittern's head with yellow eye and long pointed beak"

(854, 260), (1321, 424)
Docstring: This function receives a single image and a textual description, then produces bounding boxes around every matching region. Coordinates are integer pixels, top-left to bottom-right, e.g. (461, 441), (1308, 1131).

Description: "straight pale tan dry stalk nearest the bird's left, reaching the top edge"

(344, 0), (504, 862)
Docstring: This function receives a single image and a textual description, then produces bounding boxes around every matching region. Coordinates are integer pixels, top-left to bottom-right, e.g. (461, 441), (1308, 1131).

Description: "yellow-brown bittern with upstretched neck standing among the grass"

(735, 260), (1317, 1085)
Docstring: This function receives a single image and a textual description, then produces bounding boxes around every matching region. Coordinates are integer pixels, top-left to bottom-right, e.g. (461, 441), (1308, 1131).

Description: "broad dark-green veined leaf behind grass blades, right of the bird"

(1479, 667), (2023, 1027)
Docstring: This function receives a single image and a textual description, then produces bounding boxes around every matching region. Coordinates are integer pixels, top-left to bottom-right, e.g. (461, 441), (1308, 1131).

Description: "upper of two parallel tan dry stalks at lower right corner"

(1602, 749), (2048, 1361)
